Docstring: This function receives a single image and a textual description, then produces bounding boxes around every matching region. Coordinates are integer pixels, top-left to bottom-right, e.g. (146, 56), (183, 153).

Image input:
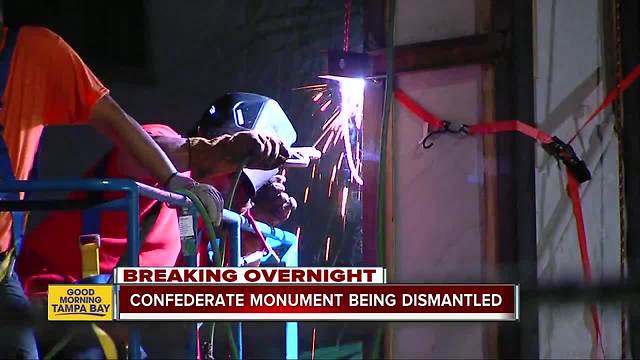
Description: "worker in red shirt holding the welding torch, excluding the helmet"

(17, 93), (297, 358)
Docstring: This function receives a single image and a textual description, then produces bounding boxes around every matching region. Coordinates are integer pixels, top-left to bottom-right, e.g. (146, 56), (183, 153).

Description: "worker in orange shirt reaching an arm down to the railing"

(0, 21), (222, 358)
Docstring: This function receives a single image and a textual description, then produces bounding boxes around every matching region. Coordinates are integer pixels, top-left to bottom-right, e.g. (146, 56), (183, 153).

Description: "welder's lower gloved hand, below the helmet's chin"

(251, 175), (298, 226)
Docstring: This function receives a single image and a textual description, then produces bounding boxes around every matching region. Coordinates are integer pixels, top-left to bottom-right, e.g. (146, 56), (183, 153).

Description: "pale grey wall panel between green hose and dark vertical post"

(392, 0), (484, 359)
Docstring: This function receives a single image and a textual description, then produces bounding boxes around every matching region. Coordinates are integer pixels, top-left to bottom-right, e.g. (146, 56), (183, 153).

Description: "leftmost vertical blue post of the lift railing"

(127, 190), (141, 360)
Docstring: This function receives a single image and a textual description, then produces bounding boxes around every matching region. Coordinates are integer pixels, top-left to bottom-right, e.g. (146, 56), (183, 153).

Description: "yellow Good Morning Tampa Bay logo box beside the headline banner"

(47, 285), (113, 321)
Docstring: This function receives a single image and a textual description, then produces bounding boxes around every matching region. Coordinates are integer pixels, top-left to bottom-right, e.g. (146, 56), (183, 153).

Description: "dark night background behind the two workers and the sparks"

(3, 0), (366, 358)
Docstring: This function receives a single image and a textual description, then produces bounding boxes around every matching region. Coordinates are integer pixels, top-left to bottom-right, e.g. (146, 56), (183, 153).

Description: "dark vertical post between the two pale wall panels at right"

(491, 0), (540, 359)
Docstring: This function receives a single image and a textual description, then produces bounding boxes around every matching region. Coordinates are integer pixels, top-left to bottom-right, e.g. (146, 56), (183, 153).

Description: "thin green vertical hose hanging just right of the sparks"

(371, 0), (396, 359)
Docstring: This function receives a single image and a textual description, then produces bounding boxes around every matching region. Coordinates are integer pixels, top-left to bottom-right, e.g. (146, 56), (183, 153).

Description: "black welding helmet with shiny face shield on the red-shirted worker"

(198, 92), (297, 192)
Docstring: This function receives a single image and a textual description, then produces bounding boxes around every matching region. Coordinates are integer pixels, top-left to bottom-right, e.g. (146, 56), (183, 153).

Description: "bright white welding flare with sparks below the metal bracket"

(314, 78), (365, 185)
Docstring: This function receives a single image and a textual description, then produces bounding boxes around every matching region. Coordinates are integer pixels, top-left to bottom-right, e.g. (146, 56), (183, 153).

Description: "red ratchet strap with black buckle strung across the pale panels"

(394, 86), (604, 356)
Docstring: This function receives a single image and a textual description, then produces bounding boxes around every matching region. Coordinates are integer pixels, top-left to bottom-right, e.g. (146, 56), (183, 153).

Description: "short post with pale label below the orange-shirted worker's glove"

(178, 205), (198, 359)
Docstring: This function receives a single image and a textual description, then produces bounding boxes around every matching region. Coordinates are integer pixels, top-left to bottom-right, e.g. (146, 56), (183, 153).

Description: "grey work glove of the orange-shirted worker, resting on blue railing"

(166, 174), (224, 226)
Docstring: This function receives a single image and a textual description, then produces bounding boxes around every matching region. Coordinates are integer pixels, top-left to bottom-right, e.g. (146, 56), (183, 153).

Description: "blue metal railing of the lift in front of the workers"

(0, 179), (298, 359)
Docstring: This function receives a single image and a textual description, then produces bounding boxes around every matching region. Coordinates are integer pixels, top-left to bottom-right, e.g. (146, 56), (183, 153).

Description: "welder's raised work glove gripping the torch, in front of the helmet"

(189, 131), (289, 178)
